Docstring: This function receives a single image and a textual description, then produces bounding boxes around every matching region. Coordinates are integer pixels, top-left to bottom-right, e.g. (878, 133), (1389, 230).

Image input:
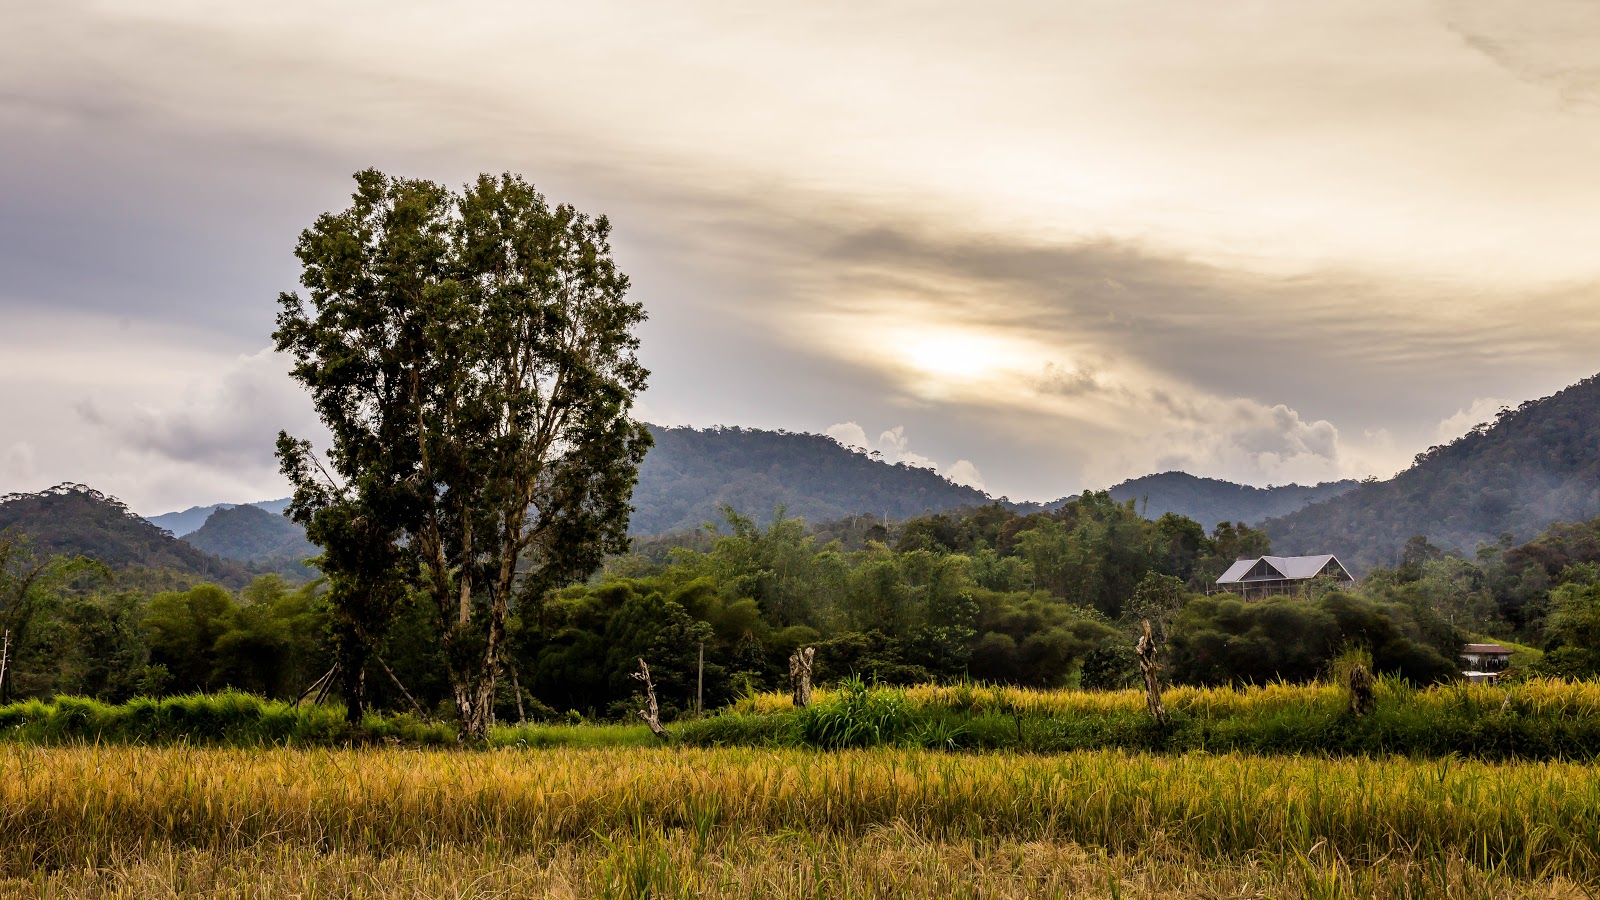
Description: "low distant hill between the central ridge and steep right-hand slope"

(1109, 472), (1357, 528)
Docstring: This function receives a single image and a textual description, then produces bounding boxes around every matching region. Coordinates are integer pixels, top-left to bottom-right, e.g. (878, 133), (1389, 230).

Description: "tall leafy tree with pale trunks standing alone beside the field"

(274, 170), (650, 735)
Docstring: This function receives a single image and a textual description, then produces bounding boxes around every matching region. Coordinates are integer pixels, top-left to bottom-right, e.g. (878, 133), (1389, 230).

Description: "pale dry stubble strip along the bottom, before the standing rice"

(9, 826), (1590, 900)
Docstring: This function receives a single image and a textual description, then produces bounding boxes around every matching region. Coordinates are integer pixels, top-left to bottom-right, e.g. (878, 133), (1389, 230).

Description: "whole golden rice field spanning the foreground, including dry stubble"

(0, 743), (1600, 897)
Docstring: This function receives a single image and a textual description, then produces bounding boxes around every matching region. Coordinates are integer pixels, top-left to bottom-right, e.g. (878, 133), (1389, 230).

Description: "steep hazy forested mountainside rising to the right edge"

(1266, 376), (1600, 569)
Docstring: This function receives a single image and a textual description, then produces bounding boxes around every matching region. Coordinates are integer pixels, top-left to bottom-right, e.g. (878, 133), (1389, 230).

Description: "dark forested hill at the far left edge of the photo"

(0, 484), (253, 588)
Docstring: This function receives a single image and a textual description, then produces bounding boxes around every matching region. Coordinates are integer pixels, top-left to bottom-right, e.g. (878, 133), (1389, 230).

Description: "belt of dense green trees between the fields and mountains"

(0, 493), (1600, 719)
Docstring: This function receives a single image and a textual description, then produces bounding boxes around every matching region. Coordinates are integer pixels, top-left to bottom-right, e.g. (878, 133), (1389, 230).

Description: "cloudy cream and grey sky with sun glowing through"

(0, 0), (1600, 514)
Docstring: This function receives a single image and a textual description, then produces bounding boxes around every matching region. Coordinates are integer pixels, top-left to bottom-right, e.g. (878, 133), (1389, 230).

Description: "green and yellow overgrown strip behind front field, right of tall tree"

(675, 675), (1600, 761)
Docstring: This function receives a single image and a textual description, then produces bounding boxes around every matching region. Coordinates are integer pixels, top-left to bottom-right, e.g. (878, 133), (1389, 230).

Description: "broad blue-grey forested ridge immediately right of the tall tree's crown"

(629, 426), (989, 535)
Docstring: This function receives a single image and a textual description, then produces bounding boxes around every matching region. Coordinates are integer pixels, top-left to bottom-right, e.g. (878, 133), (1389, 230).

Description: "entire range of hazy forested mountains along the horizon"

(12, 368), (1600, 583)
